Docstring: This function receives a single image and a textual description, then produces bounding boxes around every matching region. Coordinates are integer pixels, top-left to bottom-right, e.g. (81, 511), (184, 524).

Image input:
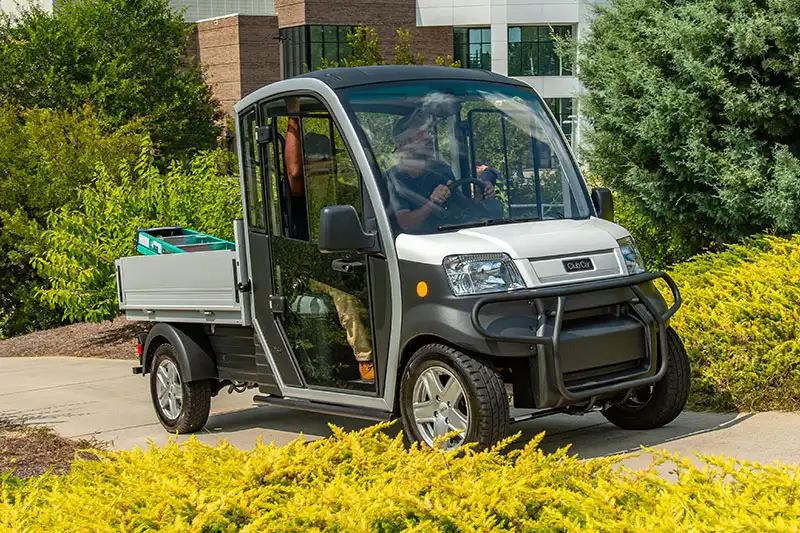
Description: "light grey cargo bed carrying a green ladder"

(116, 221), (251, 326)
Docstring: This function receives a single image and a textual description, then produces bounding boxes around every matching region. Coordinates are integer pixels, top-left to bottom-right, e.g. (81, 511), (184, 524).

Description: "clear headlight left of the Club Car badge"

(442, 254), (525, 296)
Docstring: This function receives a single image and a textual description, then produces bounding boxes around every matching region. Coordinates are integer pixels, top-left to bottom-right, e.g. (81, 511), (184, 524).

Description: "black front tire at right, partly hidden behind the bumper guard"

(603, 328), (691, 429)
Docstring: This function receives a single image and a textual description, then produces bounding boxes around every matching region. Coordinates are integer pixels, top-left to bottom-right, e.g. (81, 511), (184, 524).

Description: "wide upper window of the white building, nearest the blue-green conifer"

(508, 26), (572, 76)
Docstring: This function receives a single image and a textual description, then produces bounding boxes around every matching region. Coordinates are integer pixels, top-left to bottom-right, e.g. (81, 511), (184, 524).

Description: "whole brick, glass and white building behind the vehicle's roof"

(186, 0), (606, 143)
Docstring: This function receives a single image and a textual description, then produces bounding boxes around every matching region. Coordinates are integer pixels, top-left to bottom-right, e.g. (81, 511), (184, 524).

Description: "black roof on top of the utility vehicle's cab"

(296, 65), (529, 89)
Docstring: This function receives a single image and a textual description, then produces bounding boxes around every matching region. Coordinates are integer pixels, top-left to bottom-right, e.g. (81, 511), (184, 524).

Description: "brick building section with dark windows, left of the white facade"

(184, 0), (453, 112)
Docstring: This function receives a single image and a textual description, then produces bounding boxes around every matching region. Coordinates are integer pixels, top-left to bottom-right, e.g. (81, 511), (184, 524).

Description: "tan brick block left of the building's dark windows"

(189, 15), (281, 114)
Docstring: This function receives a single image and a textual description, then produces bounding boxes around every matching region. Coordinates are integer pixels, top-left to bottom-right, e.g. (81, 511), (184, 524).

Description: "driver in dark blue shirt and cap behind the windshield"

(389, 111), (494, 233)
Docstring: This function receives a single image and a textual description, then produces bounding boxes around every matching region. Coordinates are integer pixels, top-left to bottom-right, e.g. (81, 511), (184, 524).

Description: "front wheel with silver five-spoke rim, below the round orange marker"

(400, 344), (510, 449)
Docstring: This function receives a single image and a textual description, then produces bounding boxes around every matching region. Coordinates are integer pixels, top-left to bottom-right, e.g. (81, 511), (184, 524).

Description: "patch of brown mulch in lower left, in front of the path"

(0, 418), (104, 485)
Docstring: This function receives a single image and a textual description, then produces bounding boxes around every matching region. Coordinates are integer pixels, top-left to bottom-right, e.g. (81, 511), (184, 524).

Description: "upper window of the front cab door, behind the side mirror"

(264, 97), (361, 242)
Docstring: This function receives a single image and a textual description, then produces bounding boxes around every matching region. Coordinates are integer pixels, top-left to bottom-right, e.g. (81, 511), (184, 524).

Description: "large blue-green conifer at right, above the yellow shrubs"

(578, 0), (800, 240)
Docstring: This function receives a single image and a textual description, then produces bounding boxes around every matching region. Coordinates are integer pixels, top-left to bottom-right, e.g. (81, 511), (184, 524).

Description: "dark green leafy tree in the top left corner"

(0, 0), (221, 154)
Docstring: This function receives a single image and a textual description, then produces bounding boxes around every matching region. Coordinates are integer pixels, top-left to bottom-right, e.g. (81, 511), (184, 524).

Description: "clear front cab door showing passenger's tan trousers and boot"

(253, 96), (378, 394)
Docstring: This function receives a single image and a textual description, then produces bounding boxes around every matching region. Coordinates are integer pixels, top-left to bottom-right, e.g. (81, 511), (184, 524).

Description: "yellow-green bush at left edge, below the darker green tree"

(0, 104), (142, 338)
